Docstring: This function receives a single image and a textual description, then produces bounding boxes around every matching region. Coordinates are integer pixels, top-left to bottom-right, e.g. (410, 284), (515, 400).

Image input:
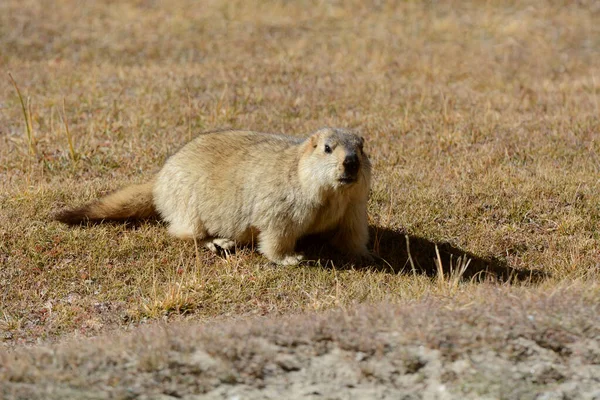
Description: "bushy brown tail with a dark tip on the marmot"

(54, 182), (158, 225)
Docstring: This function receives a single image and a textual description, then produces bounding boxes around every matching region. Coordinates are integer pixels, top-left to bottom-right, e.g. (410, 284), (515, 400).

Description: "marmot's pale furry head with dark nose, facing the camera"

(300, 128), (371, 188)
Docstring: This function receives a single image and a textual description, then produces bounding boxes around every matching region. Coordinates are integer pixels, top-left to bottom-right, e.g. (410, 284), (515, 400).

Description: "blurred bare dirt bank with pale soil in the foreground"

(0, 288), (600, 399)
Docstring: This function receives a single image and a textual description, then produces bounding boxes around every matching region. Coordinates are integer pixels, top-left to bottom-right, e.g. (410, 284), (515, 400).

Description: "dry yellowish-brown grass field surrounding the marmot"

(0, 0), (600, 396)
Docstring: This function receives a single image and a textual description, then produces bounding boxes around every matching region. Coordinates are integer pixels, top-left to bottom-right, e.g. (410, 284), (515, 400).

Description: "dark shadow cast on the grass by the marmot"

(299, 226), (547, 282)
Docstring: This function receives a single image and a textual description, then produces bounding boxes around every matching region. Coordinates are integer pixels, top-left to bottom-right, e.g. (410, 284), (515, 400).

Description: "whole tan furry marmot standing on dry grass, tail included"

(55, 128), (372, 265)
